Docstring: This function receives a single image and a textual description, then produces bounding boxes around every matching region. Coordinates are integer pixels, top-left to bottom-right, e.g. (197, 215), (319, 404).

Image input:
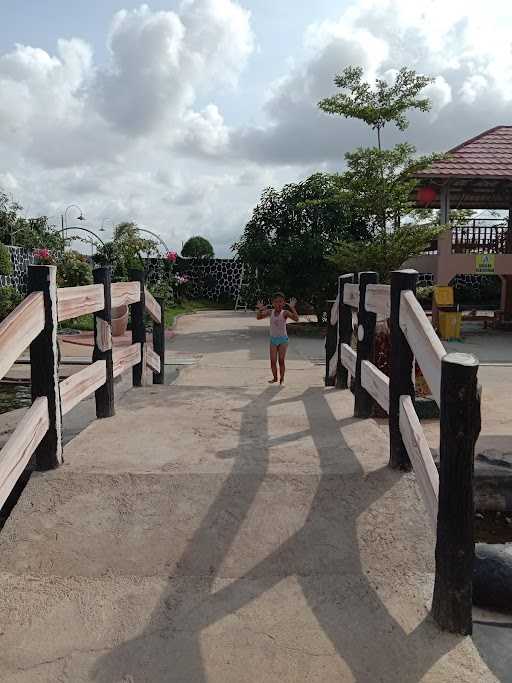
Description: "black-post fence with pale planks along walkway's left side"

(0, 266), (164, 507)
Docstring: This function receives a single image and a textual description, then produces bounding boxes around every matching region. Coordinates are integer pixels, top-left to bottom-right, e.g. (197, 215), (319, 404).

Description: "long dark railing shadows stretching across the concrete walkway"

(93, 387), (460, 683)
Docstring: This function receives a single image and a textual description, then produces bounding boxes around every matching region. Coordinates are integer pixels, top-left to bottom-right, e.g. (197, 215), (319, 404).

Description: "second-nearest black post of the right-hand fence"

(389, 270), (418, 470)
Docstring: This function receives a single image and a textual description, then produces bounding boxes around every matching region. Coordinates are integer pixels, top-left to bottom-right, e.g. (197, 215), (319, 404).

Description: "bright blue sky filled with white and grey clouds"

(0, 0), (512, 255)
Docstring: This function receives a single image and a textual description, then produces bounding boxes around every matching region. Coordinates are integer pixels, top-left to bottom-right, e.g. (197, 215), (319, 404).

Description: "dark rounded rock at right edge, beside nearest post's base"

(473, 543), (512, 613)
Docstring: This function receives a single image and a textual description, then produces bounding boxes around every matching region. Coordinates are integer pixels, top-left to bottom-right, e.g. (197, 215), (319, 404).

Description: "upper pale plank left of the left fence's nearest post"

(0, 292), (44, 379)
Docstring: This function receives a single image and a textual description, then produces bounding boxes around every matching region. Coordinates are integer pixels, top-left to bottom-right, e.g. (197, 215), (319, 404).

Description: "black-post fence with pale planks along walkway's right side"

(326, 270), (480, 634)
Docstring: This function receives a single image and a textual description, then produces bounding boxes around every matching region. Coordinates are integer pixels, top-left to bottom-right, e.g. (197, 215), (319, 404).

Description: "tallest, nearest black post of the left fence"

(28, 266), (63, 470)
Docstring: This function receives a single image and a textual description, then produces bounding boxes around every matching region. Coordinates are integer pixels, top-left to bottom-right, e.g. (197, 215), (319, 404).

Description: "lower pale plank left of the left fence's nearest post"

(0, 396), (50, 507)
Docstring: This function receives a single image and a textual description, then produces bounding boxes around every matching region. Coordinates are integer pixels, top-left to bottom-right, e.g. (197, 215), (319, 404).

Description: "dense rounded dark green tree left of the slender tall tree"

(232, 173), (371, 318)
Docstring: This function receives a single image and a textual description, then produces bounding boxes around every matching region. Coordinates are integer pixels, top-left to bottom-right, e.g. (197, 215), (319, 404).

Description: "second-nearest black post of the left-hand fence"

(92, 267), (115, 418)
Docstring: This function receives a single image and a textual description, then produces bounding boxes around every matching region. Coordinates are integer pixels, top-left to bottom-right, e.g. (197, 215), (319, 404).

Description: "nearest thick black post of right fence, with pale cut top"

(432, 353), (480, 635)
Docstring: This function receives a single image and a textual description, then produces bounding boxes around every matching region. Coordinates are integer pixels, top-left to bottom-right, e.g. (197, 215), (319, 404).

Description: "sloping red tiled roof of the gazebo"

(415, 126), (512, 180)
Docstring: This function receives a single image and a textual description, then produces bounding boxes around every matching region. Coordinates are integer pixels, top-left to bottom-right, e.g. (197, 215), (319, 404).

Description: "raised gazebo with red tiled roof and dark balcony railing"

(408, 126), (512, 319)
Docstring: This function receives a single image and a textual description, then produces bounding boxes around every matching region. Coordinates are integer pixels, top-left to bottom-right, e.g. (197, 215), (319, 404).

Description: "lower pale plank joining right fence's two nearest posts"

(400, 396), (439, 532)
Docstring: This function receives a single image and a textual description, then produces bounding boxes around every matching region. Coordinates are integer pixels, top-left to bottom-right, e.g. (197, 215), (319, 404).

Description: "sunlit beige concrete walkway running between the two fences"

(0, 312), (506, 683)
